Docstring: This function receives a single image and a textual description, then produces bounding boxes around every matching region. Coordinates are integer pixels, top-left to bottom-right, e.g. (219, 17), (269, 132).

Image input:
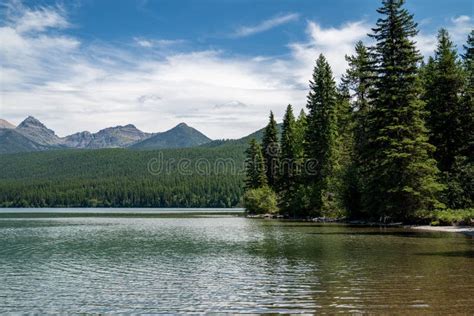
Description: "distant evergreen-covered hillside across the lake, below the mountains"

(0, 145), (245, 207)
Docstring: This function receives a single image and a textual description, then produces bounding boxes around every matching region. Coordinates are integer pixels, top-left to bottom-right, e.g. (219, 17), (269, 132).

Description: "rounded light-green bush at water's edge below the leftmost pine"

(243, 186), (278, 214)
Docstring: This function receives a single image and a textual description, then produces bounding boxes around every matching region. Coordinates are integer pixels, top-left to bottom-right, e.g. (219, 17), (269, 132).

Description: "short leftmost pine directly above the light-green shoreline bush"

(245, 139), (267, 190)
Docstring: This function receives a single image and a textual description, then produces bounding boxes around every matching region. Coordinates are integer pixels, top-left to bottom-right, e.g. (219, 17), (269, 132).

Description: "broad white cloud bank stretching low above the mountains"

(0, 3), (469, 138)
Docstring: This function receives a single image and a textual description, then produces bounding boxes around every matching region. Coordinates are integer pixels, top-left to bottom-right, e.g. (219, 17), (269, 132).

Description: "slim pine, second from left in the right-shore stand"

(262, 111), (280, 189)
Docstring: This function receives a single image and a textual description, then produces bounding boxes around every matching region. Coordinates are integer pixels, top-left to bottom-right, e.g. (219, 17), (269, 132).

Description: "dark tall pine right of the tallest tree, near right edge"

(422, 29), (474, 208)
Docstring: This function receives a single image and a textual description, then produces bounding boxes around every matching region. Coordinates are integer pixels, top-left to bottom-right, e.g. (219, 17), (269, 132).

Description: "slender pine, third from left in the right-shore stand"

(279, 104), (298, 215)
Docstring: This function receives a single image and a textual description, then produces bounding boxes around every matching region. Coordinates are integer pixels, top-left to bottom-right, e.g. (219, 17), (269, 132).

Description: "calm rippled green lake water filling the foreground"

(0, 210), (474, 314)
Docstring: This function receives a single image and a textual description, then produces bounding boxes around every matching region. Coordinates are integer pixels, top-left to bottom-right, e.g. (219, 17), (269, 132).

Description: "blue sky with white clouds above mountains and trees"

(0, 0), (474, 139)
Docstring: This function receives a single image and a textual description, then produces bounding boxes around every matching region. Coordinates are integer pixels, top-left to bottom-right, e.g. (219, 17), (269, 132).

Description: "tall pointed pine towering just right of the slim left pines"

(305, 54), (338, 211)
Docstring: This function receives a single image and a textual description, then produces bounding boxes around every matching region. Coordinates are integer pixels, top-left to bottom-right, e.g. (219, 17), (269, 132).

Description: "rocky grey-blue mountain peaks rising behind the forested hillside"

(0, 116), (212, 153)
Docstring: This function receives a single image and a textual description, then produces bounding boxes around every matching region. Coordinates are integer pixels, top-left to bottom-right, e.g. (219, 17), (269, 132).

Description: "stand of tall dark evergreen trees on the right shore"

(244, 0), (474, 222)
